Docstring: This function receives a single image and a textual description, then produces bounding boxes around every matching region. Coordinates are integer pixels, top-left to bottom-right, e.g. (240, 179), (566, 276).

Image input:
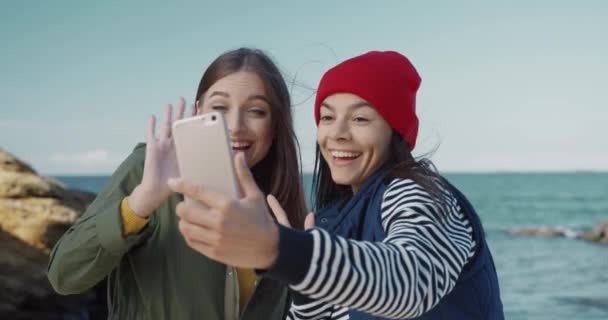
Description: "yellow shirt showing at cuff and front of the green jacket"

(120, 198), (256, 310)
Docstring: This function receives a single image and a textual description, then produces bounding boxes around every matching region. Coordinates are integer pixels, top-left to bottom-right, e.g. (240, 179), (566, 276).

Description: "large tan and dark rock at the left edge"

(0, 149), (105, 319)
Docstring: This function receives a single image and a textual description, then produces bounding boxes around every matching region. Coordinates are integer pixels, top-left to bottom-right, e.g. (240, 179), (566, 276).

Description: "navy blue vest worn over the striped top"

(315, 170), (504, 320)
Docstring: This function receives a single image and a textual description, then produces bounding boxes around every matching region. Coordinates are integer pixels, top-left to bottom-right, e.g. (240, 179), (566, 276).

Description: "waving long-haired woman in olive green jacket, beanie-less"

(48, 48), (306, 320)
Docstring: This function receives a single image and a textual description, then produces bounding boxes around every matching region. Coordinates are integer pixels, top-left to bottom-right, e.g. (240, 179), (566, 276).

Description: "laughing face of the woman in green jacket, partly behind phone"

(199, 71), (273, 168)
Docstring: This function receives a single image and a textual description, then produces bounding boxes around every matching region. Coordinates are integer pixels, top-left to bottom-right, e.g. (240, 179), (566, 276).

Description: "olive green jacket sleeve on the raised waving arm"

(48, 144), (156, 294)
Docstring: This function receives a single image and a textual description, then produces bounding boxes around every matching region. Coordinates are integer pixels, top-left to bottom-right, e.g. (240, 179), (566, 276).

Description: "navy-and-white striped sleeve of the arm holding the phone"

(273, 179), (475, 319)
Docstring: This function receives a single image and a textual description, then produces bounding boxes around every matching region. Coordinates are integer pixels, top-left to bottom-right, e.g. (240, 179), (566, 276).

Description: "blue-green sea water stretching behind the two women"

(54, 172), (608, 320)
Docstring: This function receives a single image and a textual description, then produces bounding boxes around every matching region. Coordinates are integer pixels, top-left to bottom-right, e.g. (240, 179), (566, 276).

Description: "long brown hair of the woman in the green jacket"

(195, 48), (306, 228)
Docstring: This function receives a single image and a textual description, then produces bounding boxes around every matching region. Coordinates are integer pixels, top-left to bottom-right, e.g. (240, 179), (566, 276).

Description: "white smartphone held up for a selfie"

(172, 111), (240, 207)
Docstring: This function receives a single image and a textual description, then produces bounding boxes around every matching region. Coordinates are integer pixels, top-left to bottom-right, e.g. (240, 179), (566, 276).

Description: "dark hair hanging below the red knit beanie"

(312, 130), (446, 211)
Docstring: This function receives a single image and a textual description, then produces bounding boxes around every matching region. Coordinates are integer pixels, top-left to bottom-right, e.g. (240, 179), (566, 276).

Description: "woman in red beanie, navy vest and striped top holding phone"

(170, 51), (504, 319)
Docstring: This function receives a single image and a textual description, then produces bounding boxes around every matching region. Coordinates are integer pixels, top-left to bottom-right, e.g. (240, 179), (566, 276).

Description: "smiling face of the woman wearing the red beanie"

(317, 93), (392, 192)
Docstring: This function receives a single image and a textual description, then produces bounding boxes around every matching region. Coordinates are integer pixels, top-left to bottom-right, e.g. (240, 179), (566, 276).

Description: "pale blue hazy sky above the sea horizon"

(0, 0), (608, 174)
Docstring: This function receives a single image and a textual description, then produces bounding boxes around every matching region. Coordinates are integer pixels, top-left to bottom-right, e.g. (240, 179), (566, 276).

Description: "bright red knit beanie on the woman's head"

(315, 51), (421, 150)
